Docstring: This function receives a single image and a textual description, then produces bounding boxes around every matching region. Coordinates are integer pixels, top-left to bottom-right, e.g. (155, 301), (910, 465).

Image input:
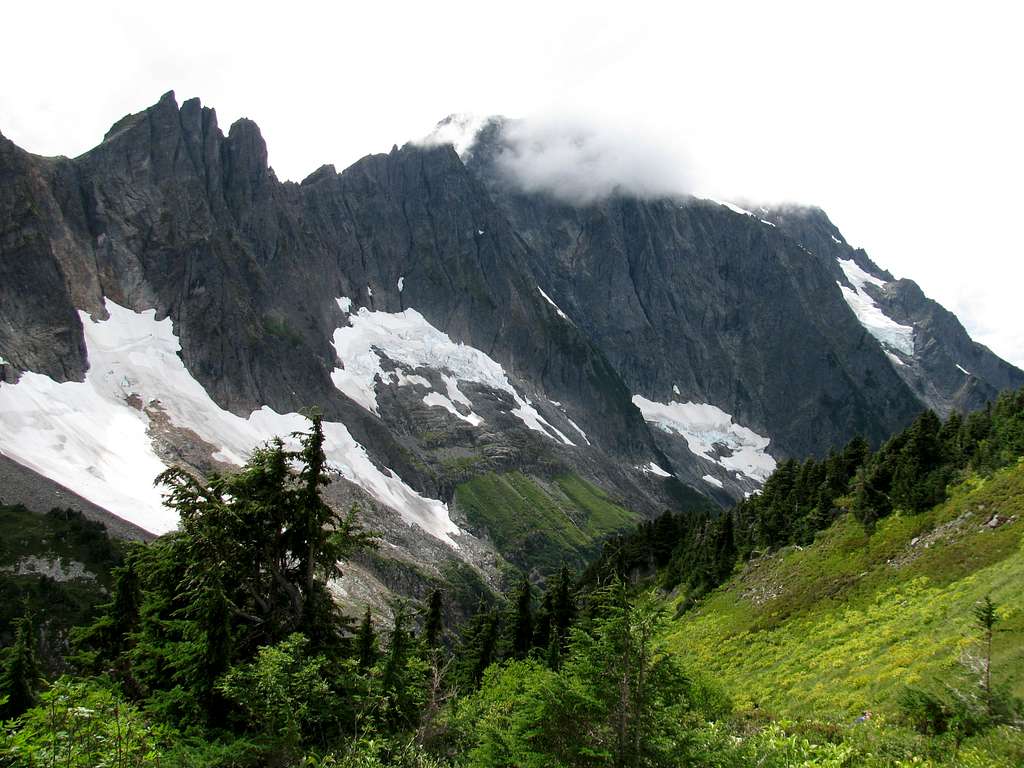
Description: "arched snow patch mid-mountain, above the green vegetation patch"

(331, 297), (575, 445)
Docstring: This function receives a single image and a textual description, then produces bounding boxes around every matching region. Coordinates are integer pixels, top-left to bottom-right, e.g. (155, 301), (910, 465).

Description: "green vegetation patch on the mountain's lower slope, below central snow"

(455, 472), (639, 571)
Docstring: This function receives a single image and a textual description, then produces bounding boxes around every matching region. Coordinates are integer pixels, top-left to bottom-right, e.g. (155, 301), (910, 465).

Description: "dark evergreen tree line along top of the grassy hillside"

(582, 389), (1024, 601)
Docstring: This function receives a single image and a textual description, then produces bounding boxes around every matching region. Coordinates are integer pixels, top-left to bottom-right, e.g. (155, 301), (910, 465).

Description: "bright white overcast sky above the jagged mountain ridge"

(0, 0), (1024, 367)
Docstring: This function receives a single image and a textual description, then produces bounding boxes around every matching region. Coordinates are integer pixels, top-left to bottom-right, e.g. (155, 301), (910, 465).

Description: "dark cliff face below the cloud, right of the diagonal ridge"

(464, 119), (1024, 479)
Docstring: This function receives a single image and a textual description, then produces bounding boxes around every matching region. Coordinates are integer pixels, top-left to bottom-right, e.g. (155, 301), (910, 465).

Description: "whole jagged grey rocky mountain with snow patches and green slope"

(0, 93), (1024, 614)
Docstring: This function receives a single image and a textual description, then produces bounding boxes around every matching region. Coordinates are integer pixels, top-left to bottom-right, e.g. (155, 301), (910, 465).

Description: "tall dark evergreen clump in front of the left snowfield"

(112, 417), (373, 724)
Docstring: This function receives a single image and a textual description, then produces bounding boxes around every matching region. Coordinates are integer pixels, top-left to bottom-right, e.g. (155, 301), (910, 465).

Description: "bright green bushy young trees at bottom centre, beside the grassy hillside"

(450, 583), (689, 767)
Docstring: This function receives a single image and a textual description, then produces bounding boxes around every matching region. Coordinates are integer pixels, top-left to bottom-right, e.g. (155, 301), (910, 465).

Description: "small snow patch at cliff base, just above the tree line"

(633, 394), (775, 482)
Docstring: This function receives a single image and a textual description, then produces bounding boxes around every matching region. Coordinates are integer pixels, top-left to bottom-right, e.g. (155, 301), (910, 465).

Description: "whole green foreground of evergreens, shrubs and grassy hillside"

(0, 390), (1024, 768)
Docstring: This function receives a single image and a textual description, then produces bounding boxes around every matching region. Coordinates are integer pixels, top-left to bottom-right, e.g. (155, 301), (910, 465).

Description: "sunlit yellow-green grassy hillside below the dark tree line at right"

(670, 462), (1024, 719)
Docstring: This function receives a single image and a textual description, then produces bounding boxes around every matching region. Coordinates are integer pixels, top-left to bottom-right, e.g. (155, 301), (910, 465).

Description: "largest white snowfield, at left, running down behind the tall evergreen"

(0, 299), (460, 547)
